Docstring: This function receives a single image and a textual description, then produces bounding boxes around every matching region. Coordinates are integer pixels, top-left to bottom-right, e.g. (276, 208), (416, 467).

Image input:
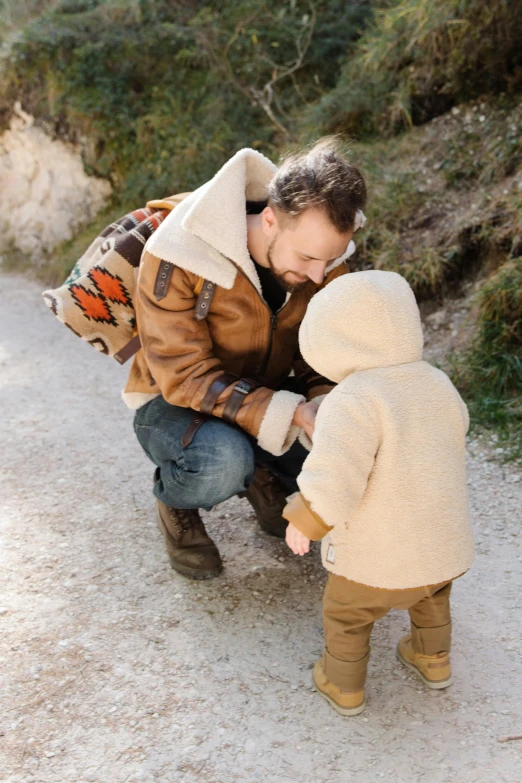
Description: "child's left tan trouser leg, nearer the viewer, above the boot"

(323, 574), (389, 693)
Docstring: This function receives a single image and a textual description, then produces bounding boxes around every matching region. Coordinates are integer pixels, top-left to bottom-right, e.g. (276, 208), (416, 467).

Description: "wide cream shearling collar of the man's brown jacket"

(145, 148), (355, 294)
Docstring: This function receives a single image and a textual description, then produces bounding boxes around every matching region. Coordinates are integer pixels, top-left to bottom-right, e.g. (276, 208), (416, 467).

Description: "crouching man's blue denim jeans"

(134, 397), (308, 511)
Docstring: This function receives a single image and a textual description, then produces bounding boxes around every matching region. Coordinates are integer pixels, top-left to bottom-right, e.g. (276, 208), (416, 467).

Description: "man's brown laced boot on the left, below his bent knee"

(156, 500), (223, 579)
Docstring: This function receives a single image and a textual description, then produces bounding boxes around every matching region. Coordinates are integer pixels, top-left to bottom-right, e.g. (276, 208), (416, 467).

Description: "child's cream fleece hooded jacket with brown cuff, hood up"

(284, 271), (473, 589)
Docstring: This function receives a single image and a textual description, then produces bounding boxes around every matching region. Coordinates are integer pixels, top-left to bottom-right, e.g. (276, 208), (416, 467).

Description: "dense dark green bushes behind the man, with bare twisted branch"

(0, 0), (369, 202)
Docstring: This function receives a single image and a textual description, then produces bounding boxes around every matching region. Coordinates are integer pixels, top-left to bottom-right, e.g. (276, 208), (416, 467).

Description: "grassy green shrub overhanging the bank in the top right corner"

(305, 0), (522, 136)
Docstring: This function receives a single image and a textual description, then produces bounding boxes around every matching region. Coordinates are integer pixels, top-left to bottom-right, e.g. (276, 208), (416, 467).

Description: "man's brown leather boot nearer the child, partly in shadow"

(239, 465), (290, 538)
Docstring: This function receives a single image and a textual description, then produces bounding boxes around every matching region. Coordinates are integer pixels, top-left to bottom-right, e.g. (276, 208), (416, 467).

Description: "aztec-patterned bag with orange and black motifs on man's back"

(42, 205), (169, 361)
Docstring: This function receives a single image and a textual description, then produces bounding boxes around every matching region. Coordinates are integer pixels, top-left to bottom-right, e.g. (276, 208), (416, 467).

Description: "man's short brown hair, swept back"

(268, 136), (366, 234)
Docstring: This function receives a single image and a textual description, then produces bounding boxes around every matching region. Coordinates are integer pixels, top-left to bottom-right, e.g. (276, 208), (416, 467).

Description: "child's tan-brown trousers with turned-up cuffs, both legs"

(323, 574), (451, 691)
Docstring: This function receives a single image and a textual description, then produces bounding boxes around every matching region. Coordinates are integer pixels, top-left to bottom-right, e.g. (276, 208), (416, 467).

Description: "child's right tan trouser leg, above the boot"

(408, 582), (452, 655)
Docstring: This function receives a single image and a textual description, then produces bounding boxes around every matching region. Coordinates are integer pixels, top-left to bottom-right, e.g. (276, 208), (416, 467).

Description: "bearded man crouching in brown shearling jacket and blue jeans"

(123, 139), (366, 579)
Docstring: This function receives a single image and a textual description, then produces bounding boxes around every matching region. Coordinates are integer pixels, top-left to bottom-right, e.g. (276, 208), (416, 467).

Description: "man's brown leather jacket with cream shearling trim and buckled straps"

(123, 150), (348, 454)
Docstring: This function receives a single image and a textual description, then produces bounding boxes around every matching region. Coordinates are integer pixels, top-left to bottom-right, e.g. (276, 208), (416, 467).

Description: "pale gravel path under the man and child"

(0, 274), (522, 783)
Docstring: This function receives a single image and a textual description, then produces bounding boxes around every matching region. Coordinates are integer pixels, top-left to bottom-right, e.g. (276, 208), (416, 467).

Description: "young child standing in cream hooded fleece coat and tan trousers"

(284, 271), (473, 715)
